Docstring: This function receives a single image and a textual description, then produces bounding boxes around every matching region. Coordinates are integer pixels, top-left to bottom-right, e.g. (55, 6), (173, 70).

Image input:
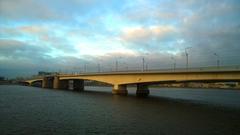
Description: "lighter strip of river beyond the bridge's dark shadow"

(86, 86), (240, 108)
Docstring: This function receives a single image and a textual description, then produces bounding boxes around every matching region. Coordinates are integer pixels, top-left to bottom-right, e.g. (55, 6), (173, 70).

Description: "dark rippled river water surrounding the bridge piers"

(0, 85), (240, 135)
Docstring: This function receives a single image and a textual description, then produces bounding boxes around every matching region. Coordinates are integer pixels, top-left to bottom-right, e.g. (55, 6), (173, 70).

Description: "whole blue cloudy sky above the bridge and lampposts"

(0, 0), (240, 78)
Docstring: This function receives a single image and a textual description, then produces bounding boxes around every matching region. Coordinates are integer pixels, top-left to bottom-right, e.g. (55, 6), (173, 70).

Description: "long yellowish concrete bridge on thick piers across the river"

(24, 69), (240, 96)
